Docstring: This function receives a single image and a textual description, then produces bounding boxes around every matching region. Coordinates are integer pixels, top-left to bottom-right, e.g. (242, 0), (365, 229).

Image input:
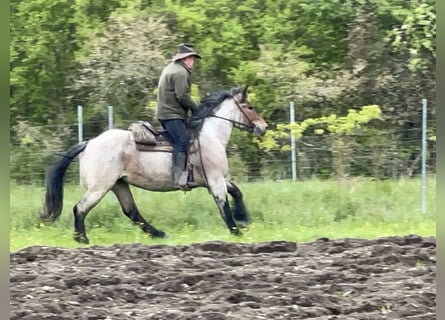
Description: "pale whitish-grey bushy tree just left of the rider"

(71, 13), (173, 130)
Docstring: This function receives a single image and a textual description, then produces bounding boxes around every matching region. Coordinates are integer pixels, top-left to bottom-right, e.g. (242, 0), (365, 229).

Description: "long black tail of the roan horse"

(40, 141), (87, 221)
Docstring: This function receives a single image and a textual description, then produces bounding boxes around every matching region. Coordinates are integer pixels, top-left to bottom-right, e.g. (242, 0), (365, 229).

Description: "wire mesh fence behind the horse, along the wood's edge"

(11, 119), (436, 184)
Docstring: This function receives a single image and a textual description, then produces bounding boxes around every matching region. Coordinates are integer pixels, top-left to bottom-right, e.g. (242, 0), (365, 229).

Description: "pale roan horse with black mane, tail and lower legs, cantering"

(41, 87), (267, 243)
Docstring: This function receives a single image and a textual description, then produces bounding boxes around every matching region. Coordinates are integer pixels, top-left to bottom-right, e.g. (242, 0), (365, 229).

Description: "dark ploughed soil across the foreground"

(10, 235), (436, 320)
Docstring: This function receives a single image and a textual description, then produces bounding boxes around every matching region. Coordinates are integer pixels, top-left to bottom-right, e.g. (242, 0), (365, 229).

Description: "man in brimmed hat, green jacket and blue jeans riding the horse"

(157, 44), (201, 190)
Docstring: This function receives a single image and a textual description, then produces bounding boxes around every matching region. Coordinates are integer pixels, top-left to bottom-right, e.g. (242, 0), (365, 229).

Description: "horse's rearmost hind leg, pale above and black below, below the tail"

(73, 188), (108, 243)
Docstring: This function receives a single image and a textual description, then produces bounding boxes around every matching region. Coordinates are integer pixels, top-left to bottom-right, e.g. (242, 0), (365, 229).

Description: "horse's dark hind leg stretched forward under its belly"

(111, 180), (166, 238)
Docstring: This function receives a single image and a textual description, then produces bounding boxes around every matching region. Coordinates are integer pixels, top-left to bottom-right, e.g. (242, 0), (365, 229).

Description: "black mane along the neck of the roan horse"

(188, 90), (233, 131)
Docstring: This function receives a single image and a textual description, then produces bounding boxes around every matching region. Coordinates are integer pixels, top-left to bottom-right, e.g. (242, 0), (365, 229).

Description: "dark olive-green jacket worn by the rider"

(157, 61), (198, 120)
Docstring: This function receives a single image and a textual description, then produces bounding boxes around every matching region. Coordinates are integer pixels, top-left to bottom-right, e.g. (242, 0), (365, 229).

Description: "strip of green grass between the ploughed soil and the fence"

(10, 177), (436, 251)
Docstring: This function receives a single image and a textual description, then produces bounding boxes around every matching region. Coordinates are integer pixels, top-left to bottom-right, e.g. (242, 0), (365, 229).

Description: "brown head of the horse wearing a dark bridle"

(231, 86), (267, 136)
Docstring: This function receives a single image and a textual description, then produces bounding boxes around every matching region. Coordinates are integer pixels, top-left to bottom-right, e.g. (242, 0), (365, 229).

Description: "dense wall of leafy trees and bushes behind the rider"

(10, 0), (436, 182)
